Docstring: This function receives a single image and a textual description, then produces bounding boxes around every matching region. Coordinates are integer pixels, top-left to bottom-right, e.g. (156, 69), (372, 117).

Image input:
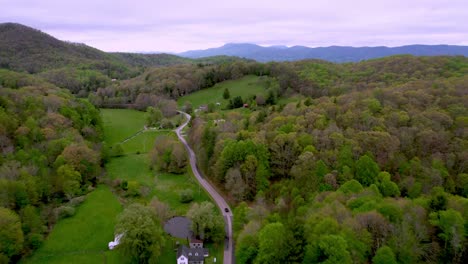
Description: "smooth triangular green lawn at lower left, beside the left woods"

(24, 185), (122, 263)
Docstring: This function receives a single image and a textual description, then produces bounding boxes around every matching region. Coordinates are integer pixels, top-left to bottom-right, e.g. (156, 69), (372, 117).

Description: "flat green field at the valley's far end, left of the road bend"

(101, 109), (145, 146)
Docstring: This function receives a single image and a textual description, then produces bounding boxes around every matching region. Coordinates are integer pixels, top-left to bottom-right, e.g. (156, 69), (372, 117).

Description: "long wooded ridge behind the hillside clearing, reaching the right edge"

(90, 56), (468, 110)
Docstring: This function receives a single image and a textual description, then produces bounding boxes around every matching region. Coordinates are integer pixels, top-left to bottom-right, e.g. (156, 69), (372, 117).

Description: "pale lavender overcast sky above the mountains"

(0, 0), (468, 52)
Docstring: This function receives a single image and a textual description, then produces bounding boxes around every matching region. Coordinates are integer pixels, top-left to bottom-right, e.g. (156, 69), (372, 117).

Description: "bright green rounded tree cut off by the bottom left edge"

(0, 207), (24, 258)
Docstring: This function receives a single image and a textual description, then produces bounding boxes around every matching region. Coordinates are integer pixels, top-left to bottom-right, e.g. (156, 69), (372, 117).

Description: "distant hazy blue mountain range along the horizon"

(178, 43), (468, 62)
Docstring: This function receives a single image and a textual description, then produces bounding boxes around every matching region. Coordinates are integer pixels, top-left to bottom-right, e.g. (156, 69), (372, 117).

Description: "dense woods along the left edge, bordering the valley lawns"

(0, 82), (102, 263)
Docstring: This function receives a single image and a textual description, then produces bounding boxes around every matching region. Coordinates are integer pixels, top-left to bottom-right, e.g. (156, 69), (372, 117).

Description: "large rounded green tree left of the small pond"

(115, 203), (165, 263)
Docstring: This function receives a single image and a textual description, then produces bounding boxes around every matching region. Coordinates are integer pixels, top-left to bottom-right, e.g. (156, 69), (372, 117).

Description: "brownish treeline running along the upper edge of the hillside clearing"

(89, 61), (264, 109)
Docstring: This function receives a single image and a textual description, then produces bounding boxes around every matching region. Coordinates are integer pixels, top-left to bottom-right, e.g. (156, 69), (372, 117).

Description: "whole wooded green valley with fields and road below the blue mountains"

(0, 23), (468, 264)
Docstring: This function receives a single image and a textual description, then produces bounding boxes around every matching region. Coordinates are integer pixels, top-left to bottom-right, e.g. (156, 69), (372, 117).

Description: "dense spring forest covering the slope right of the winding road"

(189, 61), (468, 263)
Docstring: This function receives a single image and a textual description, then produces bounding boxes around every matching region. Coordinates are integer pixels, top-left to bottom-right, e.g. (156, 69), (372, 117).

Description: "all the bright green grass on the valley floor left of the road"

(28, 109), (223, 264)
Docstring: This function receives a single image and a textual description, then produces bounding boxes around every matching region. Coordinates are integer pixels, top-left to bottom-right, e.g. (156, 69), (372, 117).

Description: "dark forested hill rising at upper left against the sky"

(0, 23), (249, 97)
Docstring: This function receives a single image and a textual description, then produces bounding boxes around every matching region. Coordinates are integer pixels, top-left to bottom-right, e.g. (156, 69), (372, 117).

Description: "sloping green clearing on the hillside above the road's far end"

(178, 75), (268, 109)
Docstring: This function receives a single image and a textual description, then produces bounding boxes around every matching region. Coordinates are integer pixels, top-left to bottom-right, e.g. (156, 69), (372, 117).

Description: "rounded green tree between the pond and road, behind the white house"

(187, 202), (224, 242)
